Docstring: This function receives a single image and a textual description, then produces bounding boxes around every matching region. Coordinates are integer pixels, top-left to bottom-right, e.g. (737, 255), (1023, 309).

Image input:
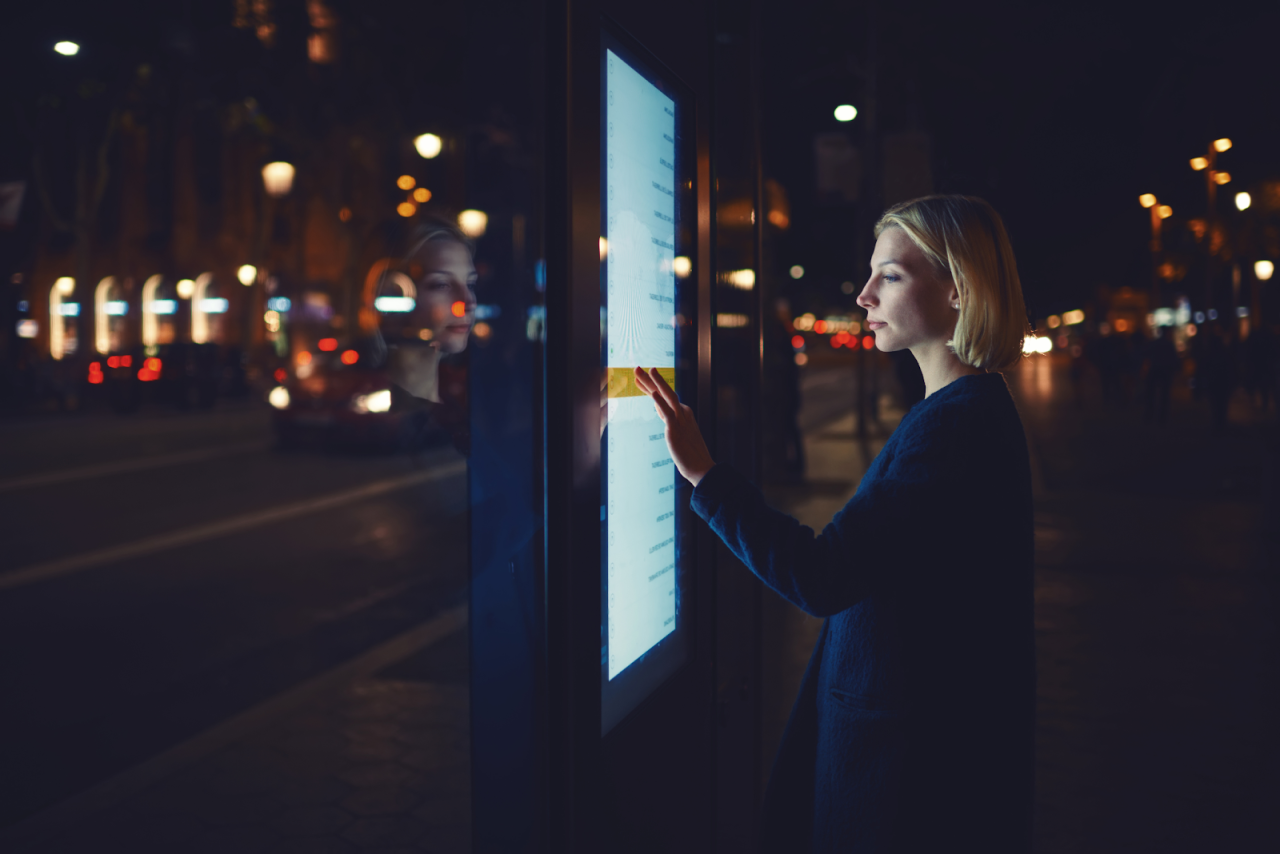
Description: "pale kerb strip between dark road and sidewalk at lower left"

(0, 604), (467, 851)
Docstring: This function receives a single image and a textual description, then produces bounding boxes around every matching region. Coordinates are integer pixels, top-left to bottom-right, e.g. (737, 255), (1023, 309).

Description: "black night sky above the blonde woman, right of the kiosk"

(762, 0), (1280, 316)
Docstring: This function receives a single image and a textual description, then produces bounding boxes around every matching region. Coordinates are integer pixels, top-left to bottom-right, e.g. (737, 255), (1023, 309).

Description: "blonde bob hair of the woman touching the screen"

(876, 196), (1029, 371)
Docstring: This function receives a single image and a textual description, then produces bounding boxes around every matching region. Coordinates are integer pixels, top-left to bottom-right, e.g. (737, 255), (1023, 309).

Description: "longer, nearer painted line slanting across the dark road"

(0, 460), (467, 592)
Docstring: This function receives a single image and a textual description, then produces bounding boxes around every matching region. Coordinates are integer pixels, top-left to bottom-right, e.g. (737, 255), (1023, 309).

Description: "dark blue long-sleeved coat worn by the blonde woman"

(692, 374), (1036, 854)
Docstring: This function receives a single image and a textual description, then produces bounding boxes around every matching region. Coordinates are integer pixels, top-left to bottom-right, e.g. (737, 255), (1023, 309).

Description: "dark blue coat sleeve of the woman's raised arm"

(692, 430), (950, 617)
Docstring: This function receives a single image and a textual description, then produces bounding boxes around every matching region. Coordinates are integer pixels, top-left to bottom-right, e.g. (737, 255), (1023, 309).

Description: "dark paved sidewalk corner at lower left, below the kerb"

(4, 621), (471, 854)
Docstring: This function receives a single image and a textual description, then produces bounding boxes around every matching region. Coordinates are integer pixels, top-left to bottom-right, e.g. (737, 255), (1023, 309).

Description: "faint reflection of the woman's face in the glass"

(413, 239), (476, 355)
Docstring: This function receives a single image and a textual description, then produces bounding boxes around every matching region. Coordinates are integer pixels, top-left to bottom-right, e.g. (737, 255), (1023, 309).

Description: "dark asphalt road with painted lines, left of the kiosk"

(0, 406), (467, 845)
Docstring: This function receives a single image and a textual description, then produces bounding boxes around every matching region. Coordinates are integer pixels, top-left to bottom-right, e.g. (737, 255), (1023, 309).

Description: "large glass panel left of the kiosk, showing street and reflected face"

(0, 0), (544, 851)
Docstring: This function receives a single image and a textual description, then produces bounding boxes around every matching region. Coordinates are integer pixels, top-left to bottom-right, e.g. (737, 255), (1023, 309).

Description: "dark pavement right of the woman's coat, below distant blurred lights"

(1010, 359), (1280, 854)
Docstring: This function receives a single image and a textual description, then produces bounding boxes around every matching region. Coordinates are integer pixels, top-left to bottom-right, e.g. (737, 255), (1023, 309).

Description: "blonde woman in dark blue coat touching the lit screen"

(636, 196), (1036, 853)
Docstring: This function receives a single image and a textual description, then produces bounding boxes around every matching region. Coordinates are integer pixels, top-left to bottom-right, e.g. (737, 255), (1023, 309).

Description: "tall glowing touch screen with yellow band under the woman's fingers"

(600, 29), (696, 734)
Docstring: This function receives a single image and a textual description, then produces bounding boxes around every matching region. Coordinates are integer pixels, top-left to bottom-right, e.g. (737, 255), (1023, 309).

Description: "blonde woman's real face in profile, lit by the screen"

(858, 227), (959, 352)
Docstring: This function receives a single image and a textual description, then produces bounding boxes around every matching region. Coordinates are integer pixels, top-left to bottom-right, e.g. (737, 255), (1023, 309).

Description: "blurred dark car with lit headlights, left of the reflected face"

(266, 348), (448, 449)
